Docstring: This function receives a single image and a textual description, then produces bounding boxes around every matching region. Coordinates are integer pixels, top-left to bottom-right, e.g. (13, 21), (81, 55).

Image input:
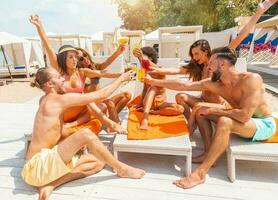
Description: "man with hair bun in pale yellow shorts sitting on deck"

(22, 68), (145, 199)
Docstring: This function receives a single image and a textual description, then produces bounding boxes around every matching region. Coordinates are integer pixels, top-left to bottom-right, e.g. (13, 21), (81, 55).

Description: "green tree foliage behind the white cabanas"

(114, 0), (278, 32)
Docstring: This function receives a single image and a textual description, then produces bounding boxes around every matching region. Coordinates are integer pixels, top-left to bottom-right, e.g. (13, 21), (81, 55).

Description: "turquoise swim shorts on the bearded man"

(251, 117), (276, 142)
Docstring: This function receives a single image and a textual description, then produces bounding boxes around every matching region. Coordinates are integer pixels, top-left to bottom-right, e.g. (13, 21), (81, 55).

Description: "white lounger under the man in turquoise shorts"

(226, 112), (278, 182)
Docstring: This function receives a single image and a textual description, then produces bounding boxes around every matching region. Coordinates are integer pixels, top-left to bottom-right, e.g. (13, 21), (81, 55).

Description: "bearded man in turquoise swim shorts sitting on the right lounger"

(145, 47), (276, 189)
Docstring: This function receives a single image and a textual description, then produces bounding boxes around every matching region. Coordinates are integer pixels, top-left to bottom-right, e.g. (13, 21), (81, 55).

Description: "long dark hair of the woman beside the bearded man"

(184, 39), (211, 81)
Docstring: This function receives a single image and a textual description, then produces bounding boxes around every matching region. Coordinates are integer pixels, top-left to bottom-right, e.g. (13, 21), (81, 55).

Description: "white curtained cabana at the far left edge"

(0, 32), (31, 77)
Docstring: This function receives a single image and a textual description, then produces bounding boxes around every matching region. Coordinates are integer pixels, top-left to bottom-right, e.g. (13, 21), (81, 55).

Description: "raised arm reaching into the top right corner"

(229, 0), (277, 49)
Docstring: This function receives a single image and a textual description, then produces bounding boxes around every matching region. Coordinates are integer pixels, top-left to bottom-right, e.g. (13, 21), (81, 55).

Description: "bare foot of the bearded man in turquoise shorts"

(174, 171), (206, 189)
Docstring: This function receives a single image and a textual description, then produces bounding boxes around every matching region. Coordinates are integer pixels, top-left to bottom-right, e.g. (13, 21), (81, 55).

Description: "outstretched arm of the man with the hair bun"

(59, 71), (134, 109)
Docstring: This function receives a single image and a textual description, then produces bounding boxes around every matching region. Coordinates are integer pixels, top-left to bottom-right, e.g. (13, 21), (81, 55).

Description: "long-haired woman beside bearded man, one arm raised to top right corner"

(146, 0), (274, 163)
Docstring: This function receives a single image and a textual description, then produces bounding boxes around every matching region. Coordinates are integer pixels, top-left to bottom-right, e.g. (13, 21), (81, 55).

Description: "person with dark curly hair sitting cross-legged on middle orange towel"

(133, 46), (184, 130)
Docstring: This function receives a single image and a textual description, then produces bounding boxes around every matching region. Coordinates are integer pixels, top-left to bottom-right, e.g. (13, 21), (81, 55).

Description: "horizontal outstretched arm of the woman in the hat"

(80, 68), (122, 78)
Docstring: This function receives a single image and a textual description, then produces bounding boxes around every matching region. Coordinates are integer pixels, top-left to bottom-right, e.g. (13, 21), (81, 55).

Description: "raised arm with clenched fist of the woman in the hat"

(29, 15), (60, 72)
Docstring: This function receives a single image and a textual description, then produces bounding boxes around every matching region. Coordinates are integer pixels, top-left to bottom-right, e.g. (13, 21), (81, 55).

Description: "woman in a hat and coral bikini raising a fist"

(30, 15), (126, 133)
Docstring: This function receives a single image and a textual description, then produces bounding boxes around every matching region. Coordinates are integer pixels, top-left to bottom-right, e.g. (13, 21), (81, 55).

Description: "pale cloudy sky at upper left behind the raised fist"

(0, 0), (122, 37)
